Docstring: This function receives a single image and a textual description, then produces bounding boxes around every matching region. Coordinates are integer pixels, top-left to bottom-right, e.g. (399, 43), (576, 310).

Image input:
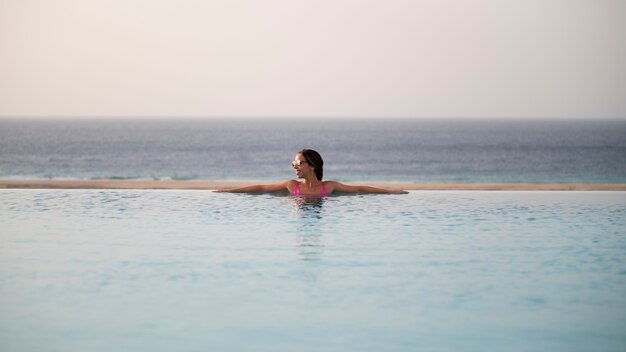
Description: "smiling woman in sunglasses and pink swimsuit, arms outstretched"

(217, 149), (408, 197)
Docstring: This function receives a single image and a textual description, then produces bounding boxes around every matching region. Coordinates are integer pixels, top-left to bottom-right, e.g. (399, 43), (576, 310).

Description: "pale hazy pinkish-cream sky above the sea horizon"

(0, 0), (626, 118)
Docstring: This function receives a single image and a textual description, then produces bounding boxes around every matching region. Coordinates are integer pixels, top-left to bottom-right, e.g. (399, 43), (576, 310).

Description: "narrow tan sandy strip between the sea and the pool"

(0, 179), (626, 191)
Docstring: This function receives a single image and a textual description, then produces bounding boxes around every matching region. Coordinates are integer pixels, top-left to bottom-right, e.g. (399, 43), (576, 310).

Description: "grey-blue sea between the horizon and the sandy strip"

(0, 119), (626, 183)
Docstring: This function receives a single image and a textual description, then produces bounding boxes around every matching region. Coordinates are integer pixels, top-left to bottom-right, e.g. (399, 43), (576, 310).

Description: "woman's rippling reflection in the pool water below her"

(293, 197), (325, 261)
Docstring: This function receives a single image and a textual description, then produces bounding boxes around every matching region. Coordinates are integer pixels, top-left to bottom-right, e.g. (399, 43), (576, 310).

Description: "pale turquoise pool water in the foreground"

(0, 190), (626, 351)
